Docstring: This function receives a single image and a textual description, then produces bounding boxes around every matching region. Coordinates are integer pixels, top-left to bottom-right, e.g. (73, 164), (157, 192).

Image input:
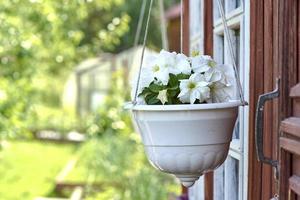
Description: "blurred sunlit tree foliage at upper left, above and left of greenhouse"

(0, 0), (178, 138)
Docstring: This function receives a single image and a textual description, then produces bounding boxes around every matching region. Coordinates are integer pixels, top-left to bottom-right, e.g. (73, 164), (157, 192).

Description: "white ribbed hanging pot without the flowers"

(131, 101), (241, 187)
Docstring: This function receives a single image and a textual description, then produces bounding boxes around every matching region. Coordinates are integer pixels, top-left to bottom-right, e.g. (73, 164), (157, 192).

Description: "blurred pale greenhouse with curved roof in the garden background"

(63, 46), (156, 116)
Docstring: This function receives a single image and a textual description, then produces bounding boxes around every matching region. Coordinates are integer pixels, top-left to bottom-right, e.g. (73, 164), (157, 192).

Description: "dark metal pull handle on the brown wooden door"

(255, 78), (280, 179)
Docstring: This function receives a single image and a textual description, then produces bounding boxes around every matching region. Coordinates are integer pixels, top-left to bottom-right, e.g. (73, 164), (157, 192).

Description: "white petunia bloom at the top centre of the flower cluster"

(170, 53), (192, 75)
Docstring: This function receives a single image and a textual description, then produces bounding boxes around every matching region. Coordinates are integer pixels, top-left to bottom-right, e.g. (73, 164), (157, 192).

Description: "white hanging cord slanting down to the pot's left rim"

(132, 0), (153, 105)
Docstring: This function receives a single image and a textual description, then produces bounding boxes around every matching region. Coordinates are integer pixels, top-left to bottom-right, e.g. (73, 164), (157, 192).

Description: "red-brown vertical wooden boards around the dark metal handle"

(248, 0), (300, 200)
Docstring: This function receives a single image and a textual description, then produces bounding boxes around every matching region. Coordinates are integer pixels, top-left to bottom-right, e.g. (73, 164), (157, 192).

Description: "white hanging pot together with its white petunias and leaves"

(126, 50), (242, 187)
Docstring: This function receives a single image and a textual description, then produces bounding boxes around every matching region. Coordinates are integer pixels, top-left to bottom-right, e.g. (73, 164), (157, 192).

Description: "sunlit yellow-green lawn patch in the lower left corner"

(0, 141), (76, 200)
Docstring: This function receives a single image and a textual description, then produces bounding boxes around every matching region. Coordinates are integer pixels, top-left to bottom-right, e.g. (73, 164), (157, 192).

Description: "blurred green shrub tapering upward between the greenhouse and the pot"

(67, 69), (180, 200)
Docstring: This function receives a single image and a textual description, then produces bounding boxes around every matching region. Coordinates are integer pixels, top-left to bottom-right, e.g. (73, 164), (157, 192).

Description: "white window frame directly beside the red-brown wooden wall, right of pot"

(213, 0), (250, 200)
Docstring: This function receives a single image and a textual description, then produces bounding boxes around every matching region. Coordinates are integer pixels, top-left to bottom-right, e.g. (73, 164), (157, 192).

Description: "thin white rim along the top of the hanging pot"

(125, 100), (243, 111)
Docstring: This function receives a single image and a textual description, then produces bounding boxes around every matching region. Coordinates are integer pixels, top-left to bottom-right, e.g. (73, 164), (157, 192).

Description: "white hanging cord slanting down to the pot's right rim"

(217, 0), (247, 105)
